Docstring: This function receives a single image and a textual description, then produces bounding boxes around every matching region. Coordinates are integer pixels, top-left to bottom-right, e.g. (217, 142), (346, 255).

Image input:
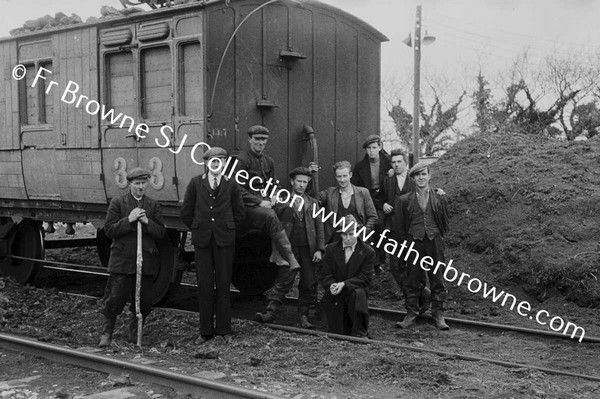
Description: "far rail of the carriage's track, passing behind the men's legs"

(6, 255), (600, 344)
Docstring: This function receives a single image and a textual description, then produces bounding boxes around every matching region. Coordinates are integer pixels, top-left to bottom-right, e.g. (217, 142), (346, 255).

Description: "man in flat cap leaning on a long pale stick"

(99, 168), (166, 347)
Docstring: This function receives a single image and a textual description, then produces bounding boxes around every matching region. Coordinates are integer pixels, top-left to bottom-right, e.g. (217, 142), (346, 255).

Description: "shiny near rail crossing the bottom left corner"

(0, 334), (282, 399)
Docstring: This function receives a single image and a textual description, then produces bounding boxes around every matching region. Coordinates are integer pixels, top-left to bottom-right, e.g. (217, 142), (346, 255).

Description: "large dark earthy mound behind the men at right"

(432, 133), (600, 307)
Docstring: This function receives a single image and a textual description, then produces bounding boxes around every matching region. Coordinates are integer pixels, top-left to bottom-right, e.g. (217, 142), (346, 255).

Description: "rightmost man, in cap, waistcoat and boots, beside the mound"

(392, 162), (449, 330)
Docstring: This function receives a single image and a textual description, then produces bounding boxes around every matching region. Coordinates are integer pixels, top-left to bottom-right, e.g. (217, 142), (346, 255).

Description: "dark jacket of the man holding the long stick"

(104, 191), (166, 275)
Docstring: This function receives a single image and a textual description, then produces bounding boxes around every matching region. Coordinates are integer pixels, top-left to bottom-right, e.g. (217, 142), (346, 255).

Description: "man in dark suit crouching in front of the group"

(321, 216), (375, 337)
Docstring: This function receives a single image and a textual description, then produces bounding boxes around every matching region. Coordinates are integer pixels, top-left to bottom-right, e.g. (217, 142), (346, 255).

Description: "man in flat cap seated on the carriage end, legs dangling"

(237, 125), (300, 271)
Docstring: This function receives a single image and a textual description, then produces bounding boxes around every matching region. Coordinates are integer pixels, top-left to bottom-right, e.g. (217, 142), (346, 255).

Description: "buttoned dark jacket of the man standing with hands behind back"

(180, 175), (246, 247)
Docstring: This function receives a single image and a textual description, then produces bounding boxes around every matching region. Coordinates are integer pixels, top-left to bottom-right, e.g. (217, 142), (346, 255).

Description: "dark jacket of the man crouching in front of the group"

(321, 240), (375, 313)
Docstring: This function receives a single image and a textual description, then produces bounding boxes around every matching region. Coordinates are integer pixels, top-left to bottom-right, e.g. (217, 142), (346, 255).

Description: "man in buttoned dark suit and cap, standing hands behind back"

(181, 147), (245, 344)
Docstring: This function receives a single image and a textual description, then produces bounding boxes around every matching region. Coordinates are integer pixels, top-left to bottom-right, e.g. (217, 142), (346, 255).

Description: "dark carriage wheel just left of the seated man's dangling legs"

(232, 231), (278, 295)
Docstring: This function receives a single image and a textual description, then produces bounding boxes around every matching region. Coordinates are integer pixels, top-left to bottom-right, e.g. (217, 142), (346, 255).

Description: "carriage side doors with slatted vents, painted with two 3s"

(100, 21), (178, 201)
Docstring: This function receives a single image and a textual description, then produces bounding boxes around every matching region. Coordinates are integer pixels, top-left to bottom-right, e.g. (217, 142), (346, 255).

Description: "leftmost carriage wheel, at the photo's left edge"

(0, 218), (44, 284)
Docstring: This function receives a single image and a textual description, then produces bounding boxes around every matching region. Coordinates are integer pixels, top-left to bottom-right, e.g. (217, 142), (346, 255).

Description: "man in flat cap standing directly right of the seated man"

(256, 167), (325, 328)
